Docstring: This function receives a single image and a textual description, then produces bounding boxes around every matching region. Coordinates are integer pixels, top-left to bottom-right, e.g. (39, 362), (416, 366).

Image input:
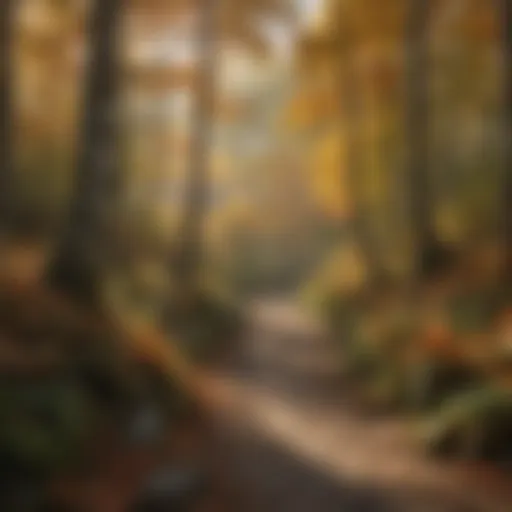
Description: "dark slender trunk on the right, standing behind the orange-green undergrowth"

(406, 0), (435, 280)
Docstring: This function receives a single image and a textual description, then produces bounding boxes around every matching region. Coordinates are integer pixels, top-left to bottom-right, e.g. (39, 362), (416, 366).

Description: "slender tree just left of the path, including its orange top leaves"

(173, 0), (285, 292)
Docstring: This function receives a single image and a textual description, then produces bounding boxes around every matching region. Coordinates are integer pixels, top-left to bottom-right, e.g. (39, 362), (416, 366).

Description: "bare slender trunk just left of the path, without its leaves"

(174, 0), (217, 292)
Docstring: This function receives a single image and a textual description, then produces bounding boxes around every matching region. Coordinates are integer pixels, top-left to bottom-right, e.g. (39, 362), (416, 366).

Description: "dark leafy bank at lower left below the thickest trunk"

(0, 282), (189, 488)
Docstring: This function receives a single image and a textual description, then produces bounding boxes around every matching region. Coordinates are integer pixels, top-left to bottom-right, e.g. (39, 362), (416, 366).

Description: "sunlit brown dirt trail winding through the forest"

(199, 300), (512, 512)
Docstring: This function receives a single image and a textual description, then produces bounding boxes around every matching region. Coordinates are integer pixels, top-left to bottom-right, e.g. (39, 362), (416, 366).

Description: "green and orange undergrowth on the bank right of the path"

(309, 239), (512, 458)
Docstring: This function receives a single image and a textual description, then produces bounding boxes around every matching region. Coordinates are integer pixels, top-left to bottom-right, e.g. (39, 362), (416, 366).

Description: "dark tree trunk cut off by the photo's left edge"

(0, 0), (15, 232)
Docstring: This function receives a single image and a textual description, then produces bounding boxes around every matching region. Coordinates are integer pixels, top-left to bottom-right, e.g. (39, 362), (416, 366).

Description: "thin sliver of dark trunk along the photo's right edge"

(499, 0), (512, 286)
